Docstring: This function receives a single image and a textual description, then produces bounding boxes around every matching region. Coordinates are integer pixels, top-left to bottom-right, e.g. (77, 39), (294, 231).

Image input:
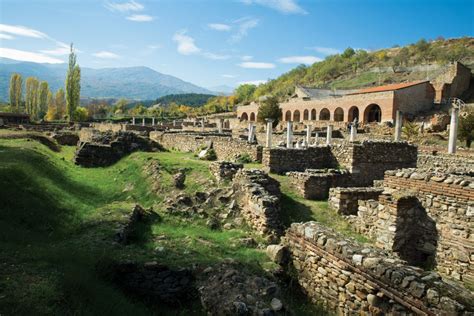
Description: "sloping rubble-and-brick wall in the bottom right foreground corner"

(283, 222), (474, 315)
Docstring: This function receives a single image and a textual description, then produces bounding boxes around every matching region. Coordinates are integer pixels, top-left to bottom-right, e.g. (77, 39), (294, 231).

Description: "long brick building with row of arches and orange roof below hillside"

(237, 63), (471, 123)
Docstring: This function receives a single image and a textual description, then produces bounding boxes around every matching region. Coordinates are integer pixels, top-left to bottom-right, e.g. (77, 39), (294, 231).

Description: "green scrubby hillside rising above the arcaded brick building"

(253, 37), (474, 99)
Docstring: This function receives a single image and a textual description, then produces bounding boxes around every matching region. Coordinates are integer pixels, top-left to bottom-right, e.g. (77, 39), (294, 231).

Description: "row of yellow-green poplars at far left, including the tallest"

(9, 44), (80, 121)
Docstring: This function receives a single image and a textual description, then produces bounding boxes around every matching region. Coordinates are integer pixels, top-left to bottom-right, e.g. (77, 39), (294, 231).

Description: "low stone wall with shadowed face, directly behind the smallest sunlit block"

(286, 169), (351, 200)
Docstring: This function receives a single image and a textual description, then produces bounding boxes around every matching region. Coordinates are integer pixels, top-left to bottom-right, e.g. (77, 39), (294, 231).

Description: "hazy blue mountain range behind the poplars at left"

(0, 58), (218, 101)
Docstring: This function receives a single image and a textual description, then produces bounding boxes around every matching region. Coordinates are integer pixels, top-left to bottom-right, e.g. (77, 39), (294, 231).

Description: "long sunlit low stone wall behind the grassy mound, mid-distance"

(150, 132), (262, 161)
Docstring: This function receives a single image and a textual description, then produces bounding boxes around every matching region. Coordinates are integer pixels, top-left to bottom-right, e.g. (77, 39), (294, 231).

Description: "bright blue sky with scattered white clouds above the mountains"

(0, 0), (474, 87)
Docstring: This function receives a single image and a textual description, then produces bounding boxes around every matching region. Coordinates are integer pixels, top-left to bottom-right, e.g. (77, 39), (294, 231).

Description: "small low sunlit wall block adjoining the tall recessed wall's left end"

(329, 187), (383, 215)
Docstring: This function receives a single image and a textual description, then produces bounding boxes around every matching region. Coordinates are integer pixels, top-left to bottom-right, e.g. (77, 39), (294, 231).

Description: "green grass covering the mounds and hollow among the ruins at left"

(0, 139), (326, 315)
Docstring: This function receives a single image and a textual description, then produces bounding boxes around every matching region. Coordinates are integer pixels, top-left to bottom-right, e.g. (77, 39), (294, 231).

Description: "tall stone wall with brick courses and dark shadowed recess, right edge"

(349, 169), (474, 284)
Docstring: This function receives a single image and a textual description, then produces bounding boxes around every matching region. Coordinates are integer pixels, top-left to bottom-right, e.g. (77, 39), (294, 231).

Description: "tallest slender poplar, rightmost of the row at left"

(66, 43), (81, 121)
